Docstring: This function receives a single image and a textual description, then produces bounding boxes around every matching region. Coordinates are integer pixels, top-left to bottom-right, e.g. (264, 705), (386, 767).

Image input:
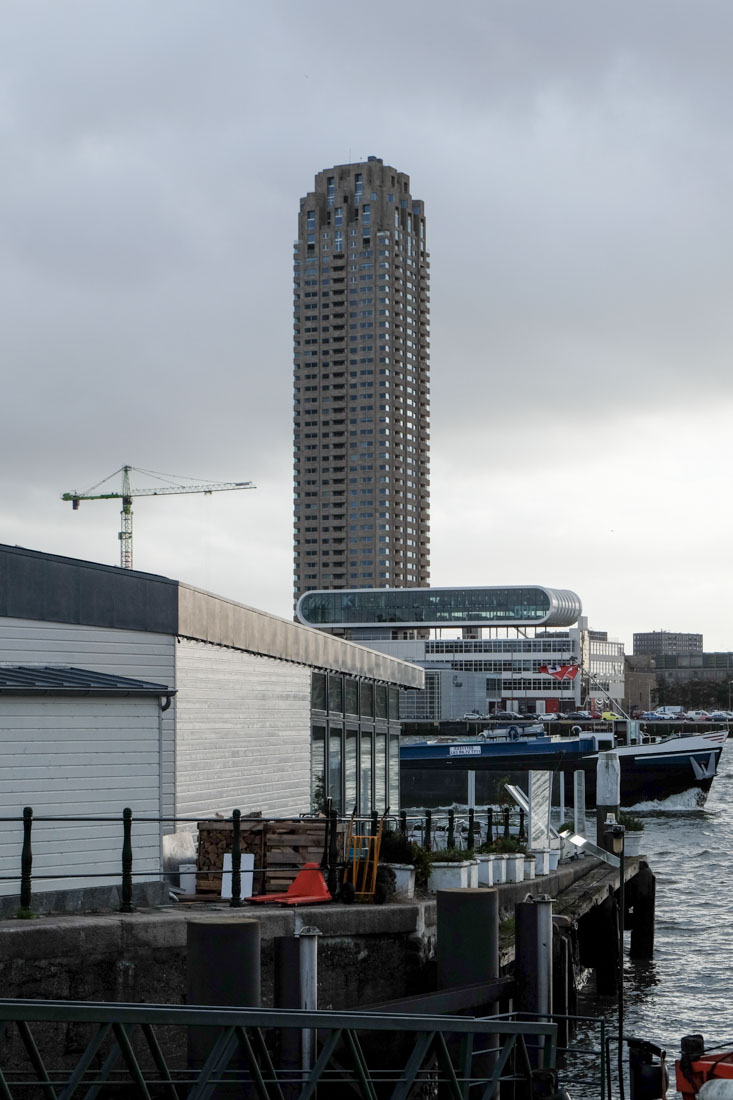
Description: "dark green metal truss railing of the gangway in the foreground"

(0, 1000), (557, 1100)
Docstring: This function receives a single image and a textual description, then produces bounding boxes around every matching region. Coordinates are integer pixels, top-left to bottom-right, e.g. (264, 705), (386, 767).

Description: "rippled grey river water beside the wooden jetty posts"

(569, 741), (733, 1100)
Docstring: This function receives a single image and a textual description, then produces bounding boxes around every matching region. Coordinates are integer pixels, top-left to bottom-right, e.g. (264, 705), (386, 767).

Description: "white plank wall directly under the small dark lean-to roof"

(0, 696), (161, 897)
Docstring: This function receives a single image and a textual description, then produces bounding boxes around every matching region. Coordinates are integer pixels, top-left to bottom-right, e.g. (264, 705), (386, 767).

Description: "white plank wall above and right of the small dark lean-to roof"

(0, 617), (176, 814)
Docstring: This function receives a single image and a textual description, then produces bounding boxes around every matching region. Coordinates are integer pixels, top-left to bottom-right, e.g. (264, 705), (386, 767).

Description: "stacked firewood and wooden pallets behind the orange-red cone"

(196, 816), (343, 895)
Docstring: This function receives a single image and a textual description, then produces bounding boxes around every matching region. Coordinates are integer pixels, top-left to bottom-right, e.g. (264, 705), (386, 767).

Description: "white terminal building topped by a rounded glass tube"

(297, 585), (624, 723)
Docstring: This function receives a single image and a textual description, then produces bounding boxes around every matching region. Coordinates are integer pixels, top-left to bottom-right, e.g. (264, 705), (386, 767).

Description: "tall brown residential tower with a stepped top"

(293, 156), (430, 601)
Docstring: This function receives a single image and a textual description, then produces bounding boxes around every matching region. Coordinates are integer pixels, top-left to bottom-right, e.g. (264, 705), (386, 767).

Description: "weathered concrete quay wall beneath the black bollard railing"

(0, 858), (635, 1009)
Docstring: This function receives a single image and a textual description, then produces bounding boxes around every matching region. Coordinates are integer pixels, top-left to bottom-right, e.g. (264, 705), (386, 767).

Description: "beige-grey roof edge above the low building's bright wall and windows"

(178, 581), (425, 688)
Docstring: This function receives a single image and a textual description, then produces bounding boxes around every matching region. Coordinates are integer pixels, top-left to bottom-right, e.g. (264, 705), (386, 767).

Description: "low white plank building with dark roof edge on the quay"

(0, 546), (424, 893)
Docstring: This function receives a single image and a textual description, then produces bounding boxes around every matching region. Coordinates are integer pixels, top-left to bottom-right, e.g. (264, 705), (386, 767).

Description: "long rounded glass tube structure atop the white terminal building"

(296, 585), (582, 629)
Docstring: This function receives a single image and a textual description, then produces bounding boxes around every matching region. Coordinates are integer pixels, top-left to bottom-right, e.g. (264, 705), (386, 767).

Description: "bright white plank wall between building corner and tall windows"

(176, 638), (310, 816)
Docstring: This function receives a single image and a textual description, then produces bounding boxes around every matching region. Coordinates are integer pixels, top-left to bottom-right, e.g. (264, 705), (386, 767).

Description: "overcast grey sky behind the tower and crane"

(0, 0), (733, 650)
